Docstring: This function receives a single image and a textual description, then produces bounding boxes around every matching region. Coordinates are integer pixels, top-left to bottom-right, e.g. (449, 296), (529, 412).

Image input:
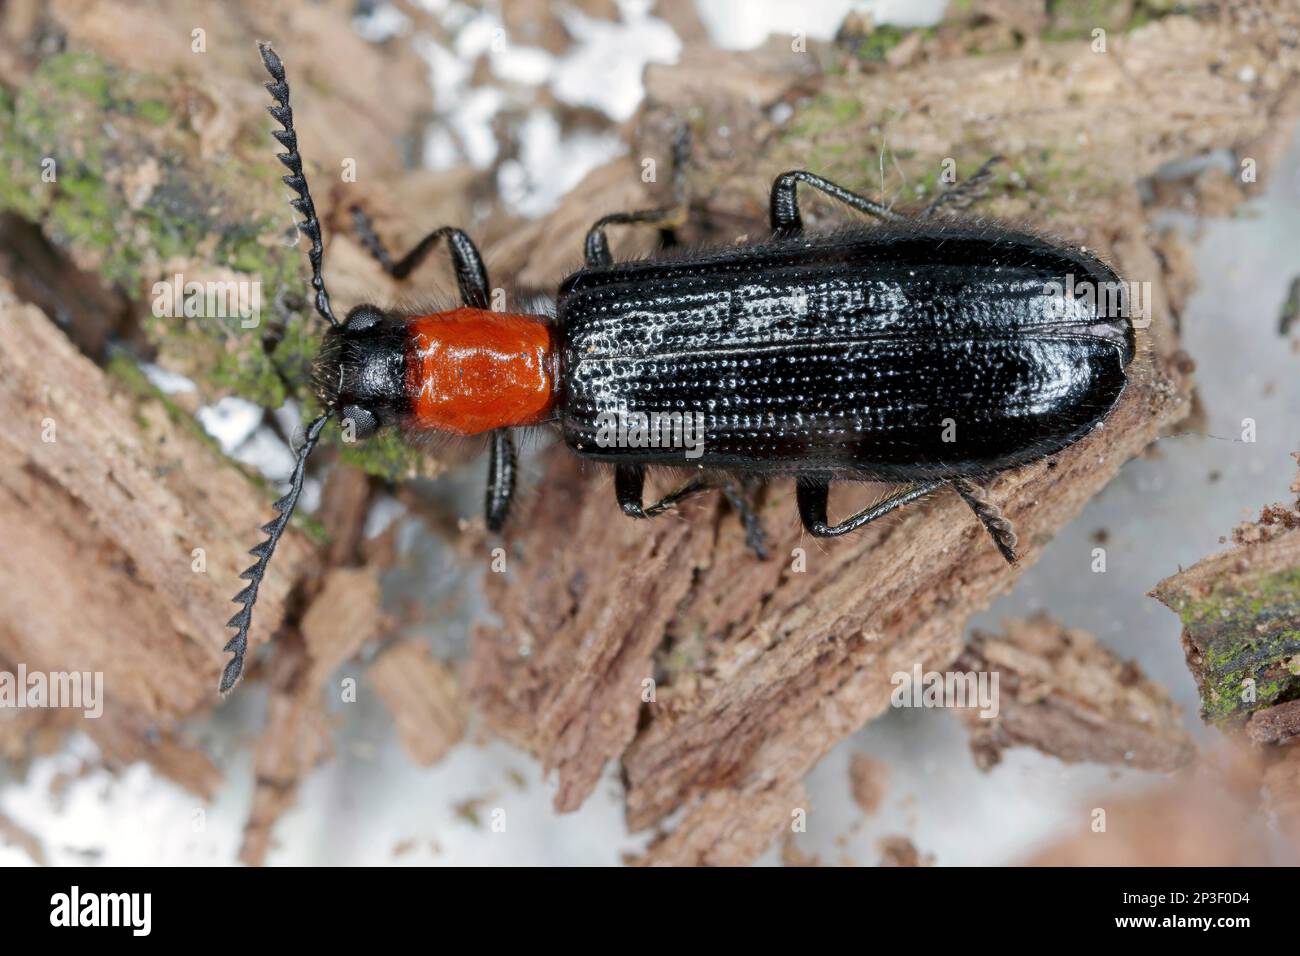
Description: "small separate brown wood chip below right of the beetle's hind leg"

(957, 614), (1196, 771)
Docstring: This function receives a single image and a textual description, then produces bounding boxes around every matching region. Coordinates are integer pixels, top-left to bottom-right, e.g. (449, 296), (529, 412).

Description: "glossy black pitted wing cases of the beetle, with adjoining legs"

(556, 157), (1135, 562)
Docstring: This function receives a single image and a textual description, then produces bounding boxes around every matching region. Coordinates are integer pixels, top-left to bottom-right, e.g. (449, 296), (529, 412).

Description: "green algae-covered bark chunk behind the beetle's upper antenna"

(0, 52), (434, 480)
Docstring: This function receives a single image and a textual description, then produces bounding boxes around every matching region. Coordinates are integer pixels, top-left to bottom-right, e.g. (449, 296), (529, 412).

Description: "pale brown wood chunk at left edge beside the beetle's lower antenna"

(0, 289), (311, 793)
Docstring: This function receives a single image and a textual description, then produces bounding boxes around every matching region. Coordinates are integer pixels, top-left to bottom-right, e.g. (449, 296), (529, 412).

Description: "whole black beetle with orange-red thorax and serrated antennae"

(221, 43), (1135, 692)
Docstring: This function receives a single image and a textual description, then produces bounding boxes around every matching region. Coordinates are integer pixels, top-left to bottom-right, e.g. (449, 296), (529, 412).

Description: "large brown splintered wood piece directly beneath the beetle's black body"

(469, 8), (1297, 862)
